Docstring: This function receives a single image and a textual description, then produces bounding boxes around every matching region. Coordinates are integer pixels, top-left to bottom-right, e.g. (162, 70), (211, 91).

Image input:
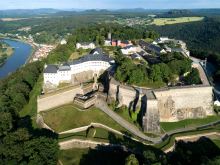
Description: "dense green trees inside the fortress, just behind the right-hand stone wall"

(115, 53), (201, 88)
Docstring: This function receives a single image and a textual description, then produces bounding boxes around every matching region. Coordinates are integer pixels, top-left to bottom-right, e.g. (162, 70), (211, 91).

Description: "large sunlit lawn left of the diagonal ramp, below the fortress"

(41, 104), (125, 132)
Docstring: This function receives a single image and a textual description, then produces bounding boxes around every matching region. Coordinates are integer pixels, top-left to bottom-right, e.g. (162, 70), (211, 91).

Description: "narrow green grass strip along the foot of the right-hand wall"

(160, 116), (220, 132)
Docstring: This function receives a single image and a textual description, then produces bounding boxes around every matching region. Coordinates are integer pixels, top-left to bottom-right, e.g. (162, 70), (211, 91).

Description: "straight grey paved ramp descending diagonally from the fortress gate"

(96, 99), (162, 143)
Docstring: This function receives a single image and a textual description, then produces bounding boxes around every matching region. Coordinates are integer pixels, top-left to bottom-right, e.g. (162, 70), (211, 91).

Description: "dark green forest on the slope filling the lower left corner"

(0, 62), (59, 165)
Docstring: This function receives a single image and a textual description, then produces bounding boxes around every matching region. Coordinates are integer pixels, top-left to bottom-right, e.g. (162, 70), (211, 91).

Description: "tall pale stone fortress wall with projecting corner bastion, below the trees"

(109, 79), (213, 132)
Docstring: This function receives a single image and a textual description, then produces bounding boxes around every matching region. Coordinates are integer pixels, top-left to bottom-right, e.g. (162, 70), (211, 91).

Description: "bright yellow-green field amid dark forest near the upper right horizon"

(151, 17), (204, 26)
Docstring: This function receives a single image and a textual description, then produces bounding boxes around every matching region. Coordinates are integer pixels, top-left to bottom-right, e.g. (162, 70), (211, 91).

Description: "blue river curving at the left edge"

(0, 39), (32, 79)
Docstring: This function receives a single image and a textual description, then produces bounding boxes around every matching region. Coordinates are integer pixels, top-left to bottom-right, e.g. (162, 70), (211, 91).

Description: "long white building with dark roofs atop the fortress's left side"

(44, 48), (114, 86)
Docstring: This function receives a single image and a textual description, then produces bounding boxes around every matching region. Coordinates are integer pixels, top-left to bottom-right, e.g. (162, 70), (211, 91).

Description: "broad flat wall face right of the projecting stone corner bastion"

(154, 86), (213, 122)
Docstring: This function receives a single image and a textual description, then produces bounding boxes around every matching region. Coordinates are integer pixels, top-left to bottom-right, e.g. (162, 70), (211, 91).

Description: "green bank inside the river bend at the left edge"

(0, 41), (14, 66)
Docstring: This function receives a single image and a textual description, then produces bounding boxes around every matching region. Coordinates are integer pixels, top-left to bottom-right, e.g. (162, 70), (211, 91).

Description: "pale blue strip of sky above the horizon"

(0, 0), (220, 9)
